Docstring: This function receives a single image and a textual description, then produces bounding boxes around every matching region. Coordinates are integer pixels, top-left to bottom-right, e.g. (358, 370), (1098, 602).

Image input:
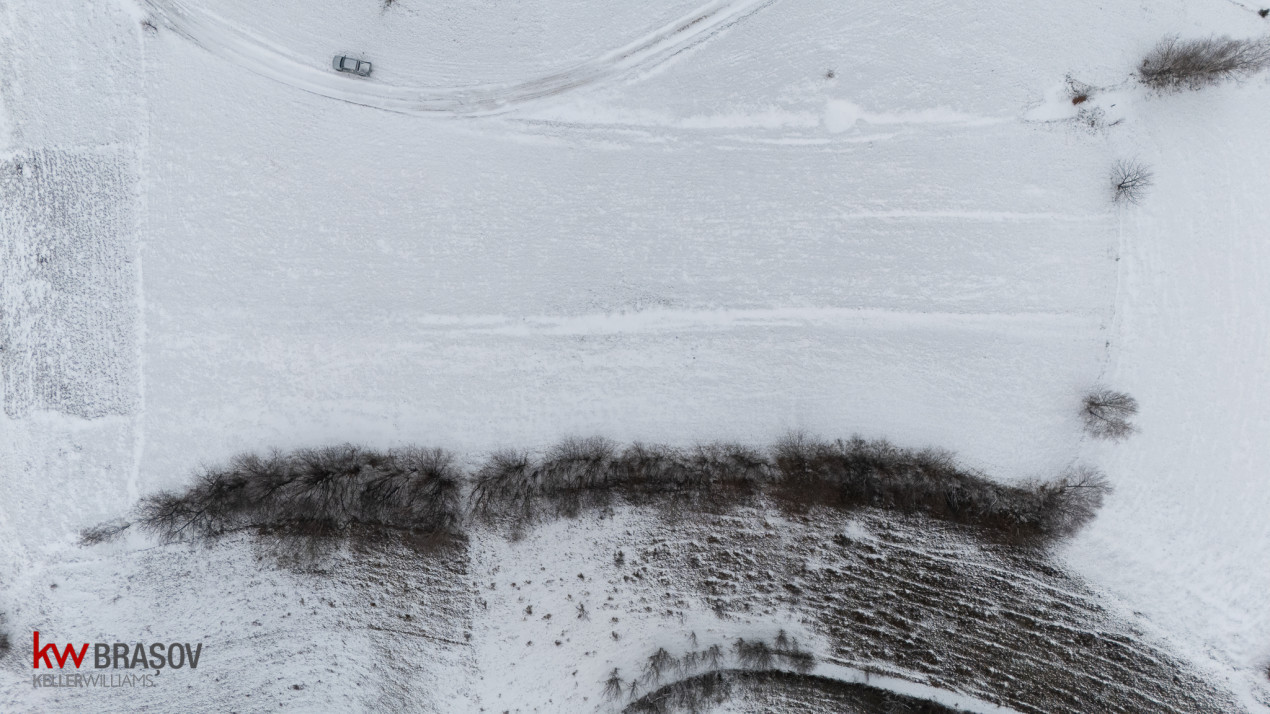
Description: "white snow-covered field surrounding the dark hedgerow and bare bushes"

(0, 0), (1270, 711)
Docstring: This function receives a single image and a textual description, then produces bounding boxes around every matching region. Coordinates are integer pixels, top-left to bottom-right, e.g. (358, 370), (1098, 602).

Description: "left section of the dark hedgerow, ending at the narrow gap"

(138, 445), (461, 541)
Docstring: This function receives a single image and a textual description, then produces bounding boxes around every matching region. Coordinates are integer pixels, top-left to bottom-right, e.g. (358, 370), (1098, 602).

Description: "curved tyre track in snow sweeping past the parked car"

(144, 0), (775, 117)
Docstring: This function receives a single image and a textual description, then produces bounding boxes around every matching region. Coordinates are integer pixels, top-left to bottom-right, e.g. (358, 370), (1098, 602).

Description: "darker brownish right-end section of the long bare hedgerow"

(773, 436), (1110, 540)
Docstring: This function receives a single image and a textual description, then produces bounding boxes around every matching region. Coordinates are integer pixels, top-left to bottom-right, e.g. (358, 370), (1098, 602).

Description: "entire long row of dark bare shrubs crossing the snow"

(131, 426), (1109, 543)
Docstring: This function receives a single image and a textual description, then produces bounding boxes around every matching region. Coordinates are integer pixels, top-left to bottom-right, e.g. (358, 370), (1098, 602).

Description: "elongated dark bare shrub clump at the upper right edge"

(1138, 36), (1270, 91)
